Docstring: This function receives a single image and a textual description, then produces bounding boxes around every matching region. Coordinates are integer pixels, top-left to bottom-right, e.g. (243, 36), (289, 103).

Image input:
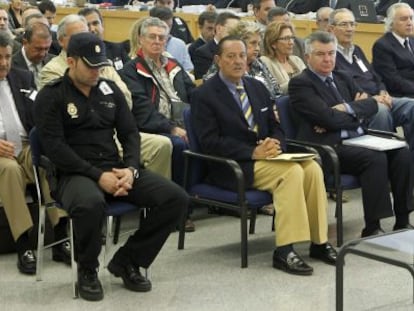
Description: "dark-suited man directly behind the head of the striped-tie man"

(192, 12), (240, 79)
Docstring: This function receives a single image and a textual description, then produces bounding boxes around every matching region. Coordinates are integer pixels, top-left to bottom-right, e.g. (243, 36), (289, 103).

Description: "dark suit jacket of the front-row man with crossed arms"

(289, 69), (378, 145)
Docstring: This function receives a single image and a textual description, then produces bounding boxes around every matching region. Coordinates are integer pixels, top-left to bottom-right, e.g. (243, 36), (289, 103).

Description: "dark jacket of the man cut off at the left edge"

(7, 68), (36, 134)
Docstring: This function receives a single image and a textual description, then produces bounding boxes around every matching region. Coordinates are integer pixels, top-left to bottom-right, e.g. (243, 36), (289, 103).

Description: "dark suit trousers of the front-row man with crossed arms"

(336, 145), (413, 224)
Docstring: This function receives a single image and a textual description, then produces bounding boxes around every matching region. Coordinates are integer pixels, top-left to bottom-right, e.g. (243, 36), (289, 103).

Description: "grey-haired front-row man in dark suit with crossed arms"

(289, 31), (413, 237)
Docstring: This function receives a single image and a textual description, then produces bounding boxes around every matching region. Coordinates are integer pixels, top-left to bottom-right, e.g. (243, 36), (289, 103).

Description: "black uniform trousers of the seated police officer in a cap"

(57, 169), (188, 268)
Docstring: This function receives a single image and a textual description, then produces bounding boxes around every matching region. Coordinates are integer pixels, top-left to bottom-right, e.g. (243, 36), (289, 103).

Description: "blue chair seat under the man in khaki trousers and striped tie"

(189, 184), (273, 208)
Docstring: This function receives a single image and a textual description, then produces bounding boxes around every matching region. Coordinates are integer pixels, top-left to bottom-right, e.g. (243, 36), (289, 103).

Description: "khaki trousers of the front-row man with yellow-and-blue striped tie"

(253, 160), (328, 246)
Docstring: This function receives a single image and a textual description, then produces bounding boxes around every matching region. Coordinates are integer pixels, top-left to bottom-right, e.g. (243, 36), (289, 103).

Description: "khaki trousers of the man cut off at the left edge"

(0, 144), (67, 241)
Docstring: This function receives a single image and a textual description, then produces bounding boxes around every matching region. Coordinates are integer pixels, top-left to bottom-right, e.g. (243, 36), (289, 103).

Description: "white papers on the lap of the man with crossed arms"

(342, 135), (407, 151)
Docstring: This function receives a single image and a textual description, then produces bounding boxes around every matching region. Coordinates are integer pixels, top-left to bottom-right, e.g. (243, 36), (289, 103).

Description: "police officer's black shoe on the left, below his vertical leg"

(78, 268), (104, 301)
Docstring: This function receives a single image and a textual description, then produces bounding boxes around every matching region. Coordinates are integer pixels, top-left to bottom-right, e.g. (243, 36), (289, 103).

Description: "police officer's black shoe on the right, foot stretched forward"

(108, 260), (152, 292)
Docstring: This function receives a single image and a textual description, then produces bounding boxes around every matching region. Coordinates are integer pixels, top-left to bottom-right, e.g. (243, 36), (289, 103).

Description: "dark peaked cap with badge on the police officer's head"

(66, 32), (110, 67)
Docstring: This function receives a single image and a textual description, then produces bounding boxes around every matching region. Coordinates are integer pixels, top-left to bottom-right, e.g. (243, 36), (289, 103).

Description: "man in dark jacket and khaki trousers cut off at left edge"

(0, 32), (66, 274)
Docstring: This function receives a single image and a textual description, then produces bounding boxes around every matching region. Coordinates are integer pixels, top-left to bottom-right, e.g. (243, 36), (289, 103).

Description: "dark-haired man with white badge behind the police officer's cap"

(78, 7), (130, 71)
